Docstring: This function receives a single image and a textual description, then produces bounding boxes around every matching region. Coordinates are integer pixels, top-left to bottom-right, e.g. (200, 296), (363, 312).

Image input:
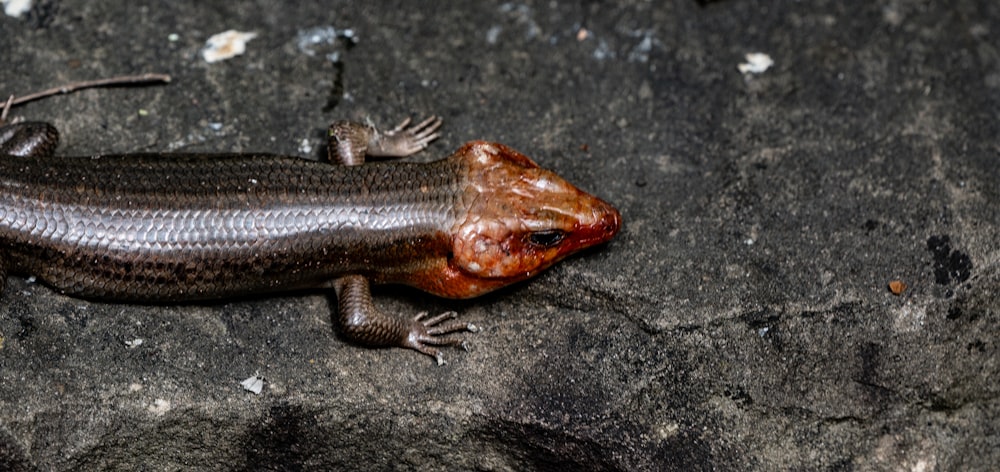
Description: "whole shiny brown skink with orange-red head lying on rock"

(0, 118), (621, 362)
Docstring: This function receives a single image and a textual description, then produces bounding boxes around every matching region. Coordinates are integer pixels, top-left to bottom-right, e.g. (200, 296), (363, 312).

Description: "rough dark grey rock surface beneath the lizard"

(0, 0), (1000, 471)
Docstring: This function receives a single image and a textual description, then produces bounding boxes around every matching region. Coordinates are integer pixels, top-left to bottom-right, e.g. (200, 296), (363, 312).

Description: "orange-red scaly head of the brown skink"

(436, 141), (621, 298)
